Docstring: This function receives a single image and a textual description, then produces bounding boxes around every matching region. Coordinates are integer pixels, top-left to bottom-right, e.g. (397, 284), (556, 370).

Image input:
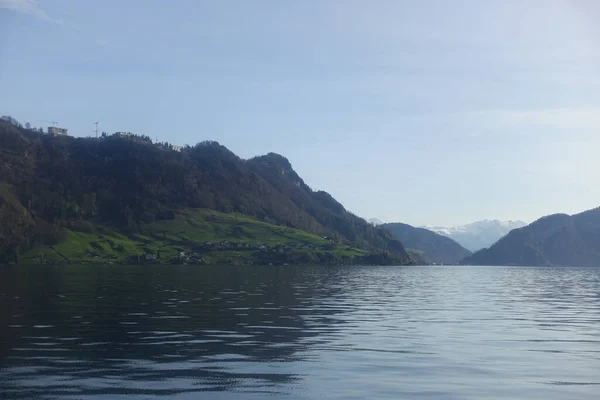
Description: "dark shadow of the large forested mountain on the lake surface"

(0, 266), (356, 398)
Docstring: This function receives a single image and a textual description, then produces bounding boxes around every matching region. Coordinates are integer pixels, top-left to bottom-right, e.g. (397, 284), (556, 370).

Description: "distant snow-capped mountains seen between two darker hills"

(424, 219), (527, 251)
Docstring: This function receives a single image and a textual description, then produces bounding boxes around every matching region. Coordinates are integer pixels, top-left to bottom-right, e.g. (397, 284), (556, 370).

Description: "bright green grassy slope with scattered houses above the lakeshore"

(20, 209), (367, 264)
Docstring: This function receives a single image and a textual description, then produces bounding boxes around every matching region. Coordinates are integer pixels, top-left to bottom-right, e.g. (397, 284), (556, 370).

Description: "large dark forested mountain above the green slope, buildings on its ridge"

(0, 120), (410, 262)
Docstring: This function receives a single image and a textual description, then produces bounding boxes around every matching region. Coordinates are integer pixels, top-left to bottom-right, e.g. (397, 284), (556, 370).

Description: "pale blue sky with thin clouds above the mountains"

(0, 0), (600, 226)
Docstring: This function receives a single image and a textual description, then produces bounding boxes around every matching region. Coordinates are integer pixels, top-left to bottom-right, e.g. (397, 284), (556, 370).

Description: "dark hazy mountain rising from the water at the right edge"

(462, 208), (600, 266)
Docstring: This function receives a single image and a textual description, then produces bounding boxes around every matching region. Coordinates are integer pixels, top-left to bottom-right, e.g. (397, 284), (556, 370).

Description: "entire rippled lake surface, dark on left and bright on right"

(0, 266), (600, 400)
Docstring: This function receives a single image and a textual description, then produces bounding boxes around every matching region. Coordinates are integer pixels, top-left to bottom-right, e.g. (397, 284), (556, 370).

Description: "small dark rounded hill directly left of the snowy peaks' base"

(381, 223), (471, 264)
